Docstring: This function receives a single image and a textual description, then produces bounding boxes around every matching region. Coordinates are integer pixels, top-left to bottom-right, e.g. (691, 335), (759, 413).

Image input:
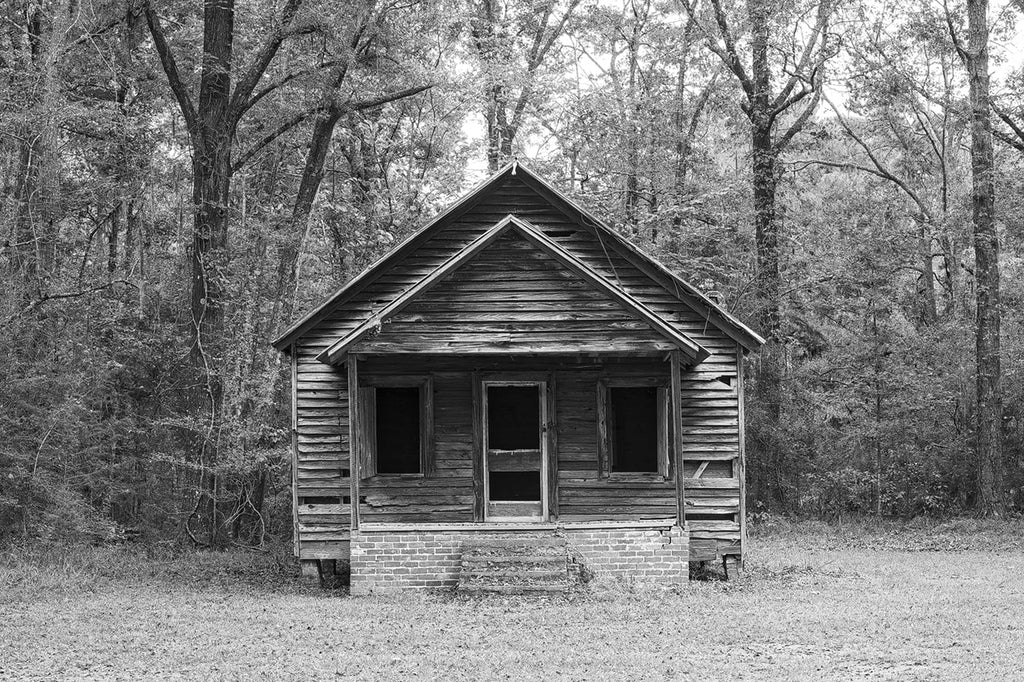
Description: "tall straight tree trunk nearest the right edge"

(961, 0), (1005, 515)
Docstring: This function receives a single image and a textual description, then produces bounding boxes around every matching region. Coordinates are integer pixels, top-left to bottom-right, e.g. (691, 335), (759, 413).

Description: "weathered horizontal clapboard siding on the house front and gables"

(288, 166), (741, 558)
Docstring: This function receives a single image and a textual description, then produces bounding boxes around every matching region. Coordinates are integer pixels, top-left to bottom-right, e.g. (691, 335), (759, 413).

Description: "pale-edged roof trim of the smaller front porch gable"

(316, 214), (711, 364)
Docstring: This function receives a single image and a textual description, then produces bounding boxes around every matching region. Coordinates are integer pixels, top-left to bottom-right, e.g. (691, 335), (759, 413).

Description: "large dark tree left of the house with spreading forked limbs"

(144, 0), (436, 544)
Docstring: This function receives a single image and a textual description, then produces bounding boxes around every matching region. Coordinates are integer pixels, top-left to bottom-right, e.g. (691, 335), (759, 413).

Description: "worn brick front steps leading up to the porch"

(457, 537), (569, 595)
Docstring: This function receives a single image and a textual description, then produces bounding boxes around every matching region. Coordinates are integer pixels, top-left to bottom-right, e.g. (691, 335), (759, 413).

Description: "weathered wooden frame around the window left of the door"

(358, 375), (434, 479)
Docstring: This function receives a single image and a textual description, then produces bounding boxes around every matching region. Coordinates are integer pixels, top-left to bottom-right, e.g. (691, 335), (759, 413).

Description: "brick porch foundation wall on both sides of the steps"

(351, 521), (689, 596)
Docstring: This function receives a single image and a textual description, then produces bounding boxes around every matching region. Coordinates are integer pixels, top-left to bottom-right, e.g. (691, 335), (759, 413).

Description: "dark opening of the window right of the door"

(608, 386), (657, 472)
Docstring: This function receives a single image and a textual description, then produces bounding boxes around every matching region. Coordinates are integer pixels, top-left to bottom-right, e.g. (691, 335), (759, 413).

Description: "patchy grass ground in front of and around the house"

(0, 521), (1024, 680)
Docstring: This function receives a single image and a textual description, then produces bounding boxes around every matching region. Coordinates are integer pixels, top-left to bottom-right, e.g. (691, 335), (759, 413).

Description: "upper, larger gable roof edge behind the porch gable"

(272, 162), (764, 350)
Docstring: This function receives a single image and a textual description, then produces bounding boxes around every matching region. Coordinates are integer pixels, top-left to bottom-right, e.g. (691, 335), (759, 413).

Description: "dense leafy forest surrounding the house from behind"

(0, 0), (1024, 547)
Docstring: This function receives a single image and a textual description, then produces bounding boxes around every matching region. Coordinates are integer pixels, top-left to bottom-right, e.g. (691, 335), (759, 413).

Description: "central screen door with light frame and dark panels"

(482, 381), (548, 521)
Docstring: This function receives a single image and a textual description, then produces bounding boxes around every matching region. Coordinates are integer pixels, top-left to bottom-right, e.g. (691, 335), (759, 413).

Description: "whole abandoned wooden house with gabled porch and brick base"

(274, 163), (763, 594)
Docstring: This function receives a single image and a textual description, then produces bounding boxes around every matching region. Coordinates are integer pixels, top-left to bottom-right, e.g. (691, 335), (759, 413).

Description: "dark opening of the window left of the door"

(375, 386), (421, 474)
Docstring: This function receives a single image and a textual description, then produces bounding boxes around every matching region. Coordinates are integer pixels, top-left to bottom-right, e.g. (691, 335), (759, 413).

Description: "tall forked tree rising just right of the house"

(685, 0), (835, 505)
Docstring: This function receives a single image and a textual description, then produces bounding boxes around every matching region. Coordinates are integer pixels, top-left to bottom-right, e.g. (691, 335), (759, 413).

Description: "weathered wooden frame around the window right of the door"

(597, 377), (674, 481)
